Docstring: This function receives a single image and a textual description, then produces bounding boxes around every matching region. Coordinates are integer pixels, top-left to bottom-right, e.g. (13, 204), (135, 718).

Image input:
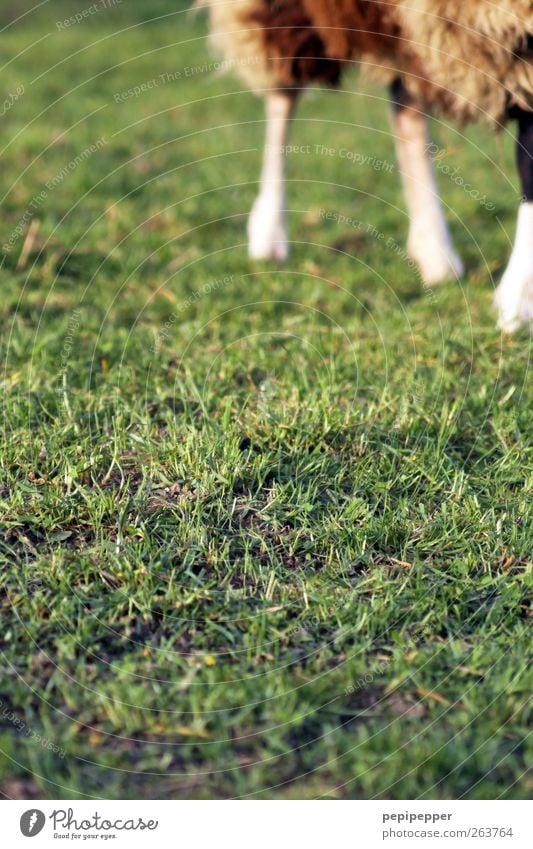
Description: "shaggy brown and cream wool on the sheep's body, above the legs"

(202, 0), (533, 123)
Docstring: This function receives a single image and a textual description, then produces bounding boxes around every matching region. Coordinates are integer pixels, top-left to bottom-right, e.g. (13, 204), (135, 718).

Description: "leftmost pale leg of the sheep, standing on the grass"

(248, 91), (296, 261)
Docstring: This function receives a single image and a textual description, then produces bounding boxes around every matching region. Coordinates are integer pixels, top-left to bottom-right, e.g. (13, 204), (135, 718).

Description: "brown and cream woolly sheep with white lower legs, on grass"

(199, 0), (533, 331)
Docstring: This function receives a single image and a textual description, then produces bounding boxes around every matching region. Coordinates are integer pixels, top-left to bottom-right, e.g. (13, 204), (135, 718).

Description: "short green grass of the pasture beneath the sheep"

(0, 0), (533, 799)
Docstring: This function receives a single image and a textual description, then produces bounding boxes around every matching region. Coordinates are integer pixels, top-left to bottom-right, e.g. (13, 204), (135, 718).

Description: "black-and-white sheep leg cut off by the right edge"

(494, 109), (533, 332)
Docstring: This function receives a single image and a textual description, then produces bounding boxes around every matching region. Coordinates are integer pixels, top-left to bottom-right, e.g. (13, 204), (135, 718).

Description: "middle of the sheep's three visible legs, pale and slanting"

(391, 80), (464, 285)
